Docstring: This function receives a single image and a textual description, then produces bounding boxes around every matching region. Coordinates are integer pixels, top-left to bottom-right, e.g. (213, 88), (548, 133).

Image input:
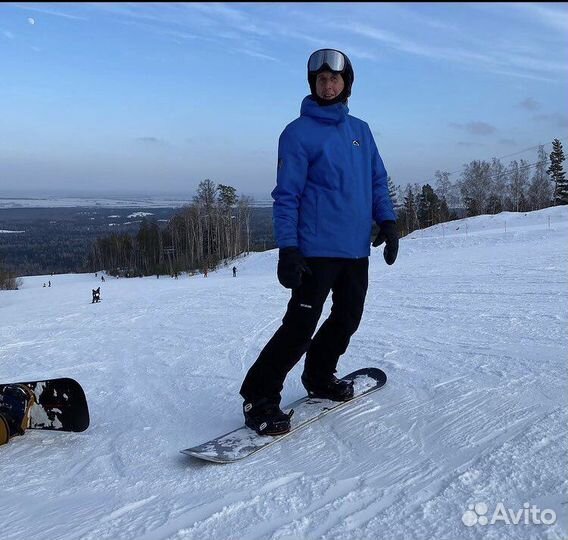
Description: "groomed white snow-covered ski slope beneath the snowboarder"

(0, 207), (568, 540)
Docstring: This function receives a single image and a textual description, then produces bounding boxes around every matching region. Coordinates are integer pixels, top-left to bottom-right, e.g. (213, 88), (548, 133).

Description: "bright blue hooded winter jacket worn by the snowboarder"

(272, 96), (396, 259)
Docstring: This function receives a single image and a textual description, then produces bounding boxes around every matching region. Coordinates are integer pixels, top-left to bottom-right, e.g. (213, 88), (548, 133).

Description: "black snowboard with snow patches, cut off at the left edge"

(0, 378), (89, 431)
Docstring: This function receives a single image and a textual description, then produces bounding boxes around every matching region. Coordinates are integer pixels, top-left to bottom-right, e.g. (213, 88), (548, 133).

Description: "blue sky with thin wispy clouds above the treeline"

(0, 3), (568, 196)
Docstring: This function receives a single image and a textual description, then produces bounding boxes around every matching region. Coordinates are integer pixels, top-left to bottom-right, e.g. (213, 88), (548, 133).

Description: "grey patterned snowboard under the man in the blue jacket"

(181, 368), (387, 463)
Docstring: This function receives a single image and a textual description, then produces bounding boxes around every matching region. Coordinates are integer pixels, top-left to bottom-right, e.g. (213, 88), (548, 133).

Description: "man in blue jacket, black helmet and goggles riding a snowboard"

(240, 49), (398, 435)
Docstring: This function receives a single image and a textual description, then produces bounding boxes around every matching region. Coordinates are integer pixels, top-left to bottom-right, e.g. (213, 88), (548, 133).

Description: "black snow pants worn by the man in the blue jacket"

(240, 257), (369, 403)
